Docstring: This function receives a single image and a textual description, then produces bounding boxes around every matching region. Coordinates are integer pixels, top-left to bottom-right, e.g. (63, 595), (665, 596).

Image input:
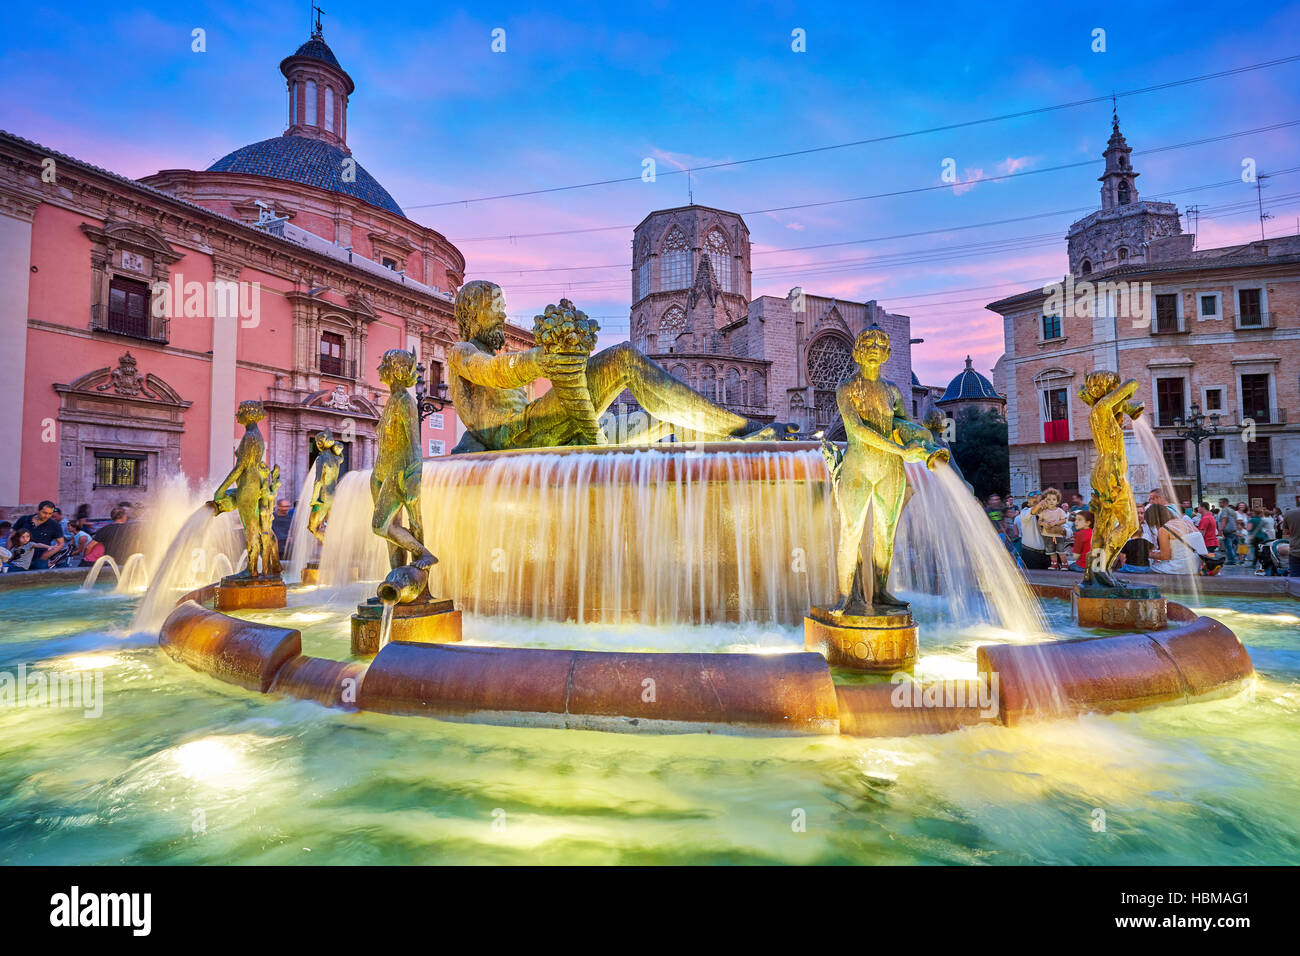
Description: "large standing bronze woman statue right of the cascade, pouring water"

(827, 325), (948, 617)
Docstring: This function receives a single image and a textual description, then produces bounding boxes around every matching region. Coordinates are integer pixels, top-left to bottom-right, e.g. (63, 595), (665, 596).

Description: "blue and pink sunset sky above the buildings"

(0, 0), (1300, 384)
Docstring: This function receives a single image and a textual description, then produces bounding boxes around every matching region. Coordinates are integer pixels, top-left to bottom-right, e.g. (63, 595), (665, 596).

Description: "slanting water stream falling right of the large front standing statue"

(891, 464), (1047, 637)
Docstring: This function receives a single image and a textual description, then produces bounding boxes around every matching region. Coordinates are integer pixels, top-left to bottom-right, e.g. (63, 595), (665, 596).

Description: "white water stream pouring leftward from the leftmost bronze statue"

(131, 505), (244, 631)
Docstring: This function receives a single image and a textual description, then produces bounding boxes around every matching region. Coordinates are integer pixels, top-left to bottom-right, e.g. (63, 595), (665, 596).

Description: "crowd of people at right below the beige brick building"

(985, 488), (1300, 576)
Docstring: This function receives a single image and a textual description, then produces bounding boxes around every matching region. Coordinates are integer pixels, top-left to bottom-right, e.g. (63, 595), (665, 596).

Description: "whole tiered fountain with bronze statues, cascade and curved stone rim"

(147, 291), (1252, 736)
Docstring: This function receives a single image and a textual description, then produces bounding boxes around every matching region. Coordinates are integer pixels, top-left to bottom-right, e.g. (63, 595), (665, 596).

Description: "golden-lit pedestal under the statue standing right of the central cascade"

(803, 607), (917, 674)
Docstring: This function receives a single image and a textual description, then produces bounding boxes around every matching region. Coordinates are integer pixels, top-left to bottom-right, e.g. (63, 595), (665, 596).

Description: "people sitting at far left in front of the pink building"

(0, 501), (137, 572)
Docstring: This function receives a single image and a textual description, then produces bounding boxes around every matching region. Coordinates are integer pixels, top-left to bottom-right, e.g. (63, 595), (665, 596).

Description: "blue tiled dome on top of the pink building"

(208, 136), (406, 219)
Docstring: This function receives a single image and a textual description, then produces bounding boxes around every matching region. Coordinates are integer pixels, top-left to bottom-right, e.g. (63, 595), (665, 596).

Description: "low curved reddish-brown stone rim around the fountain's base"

(159, 574), (1255, 737)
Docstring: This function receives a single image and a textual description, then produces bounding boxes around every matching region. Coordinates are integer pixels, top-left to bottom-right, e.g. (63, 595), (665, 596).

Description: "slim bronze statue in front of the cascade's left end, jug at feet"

(371, 349), (438, 571)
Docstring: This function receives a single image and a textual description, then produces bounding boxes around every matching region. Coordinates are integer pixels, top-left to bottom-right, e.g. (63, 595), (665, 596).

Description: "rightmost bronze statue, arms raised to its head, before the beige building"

(1079, 371), (1143, 588)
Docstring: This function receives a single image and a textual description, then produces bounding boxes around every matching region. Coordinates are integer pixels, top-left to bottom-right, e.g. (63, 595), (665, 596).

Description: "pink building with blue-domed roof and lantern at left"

(0, 24), (532, 516)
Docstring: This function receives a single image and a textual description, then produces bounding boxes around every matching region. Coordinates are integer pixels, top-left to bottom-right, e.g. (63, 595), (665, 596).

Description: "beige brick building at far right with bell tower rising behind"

(988, 113), (1300, 507)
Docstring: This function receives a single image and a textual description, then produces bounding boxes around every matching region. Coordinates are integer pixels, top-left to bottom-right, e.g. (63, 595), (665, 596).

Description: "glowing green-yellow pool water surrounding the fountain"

(0, 585), (1300, 864)
